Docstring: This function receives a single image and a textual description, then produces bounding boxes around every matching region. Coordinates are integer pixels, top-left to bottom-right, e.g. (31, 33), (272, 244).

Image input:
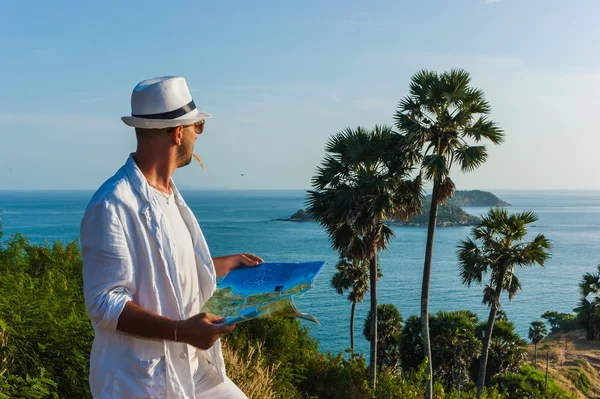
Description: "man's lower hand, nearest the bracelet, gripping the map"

(177, 313), (235, 350)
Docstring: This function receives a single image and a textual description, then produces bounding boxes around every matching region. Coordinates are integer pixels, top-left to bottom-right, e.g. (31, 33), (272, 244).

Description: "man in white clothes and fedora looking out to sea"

(81, 77), (262, 399)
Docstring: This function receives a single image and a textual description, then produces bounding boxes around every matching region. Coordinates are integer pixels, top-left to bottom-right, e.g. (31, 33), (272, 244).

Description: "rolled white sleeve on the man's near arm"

(81, 201), (135, 331)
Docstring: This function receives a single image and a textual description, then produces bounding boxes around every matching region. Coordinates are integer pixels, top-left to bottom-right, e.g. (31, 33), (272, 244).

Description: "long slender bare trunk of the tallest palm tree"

(421, 180), (440, 399)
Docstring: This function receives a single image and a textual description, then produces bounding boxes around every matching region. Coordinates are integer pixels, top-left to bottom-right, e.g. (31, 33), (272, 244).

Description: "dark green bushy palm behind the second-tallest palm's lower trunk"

(363, 303), (403, 370)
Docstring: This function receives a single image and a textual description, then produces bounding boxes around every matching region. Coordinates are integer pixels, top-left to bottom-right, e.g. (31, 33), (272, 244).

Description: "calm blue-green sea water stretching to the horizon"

(0, 190), (600, 353)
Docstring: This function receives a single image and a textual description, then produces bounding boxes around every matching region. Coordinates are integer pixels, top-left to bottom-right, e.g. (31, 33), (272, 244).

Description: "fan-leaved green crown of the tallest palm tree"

(394, 69), (504, 187)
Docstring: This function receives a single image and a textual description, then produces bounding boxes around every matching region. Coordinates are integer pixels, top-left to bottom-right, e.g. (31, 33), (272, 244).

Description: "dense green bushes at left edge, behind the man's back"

(0, 231), (93, 398)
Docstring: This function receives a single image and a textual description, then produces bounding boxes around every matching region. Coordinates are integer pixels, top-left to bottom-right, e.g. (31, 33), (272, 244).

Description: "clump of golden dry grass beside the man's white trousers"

(223, 344), (279, 399)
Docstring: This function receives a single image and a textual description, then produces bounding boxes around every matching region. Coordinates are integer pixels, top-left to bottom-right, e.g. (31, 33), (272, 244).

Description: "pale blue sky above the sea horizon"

(0, 0), (600, 189)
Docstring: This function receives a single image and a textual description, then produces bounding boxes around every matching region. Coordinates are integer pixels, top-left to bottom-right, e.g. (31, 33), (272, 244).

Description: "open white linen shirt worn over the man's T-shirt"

(81, 156), (226, 399)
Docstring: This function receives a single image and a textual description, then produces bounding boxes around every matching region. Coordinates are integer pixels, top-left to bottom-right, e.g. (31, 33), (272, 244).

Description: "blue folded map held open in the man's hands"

(202, 262), (326, 324)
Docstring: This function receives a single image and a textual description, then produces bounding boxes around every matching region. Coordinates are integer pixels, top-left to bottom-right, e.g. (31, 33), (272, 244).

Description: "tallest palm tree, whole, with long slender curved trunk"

(394, 69), (504, 399)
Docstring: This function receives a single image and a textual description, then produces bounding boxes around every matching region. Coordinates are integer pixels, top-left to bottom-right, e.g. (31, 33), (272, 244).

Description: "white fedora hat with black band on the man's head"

(121, 76), (212, 129)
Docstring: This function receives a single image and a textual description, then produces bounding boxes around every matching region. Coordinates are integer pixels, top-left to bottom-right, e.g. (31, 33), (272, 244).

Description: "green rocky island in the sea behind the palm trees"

(275, 190), (510, 227)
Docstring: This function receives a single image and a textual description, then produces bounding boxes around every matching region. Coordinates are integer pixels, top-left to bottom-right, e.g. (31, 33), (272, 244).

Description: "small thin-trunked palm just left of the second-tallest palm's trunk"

(331, 258), (369, 352)
